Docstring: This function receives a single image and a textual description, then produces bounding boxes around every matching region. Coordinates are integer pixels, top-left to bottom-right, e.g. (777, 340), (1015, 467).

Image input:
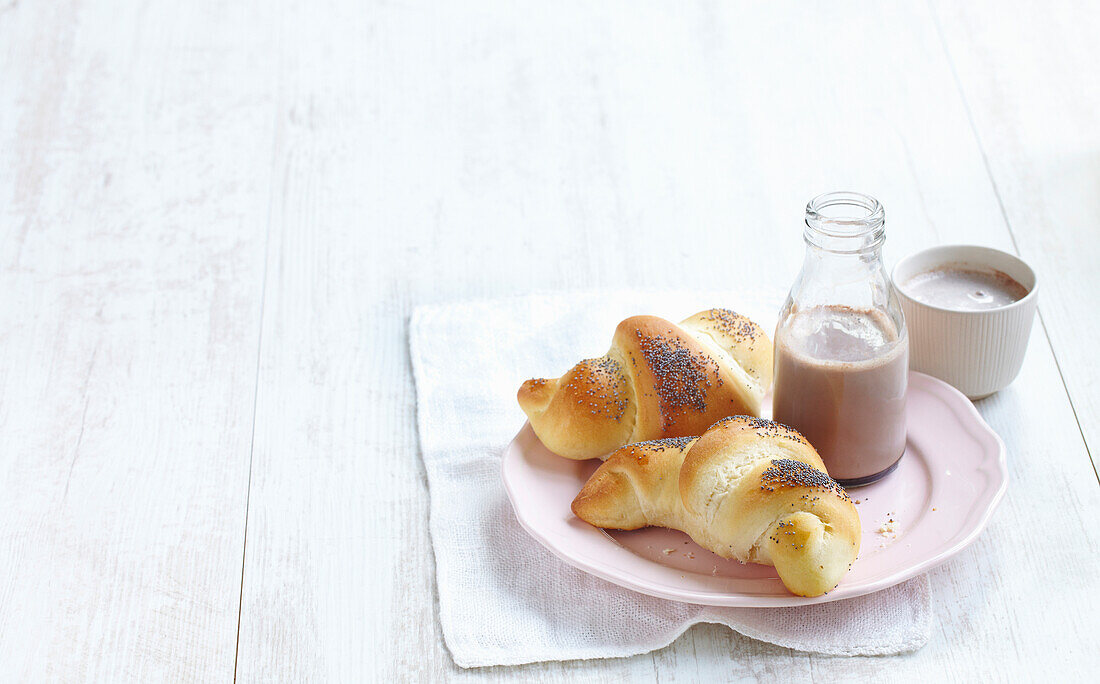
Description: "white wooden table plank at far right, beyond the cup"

(937, 1), (1100, 479)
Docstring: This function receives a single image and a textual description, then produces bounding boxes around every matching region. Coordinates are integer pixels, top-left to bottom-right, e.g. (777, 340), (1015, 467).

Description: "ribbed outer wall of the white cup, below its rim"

(900, 291), (1038, 399)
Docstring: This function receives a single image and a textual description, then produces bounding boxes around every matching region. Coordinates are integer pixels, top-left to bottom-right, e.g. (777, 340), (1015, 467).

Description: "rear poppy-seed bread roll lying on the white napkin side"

(517, 309), (772, 460)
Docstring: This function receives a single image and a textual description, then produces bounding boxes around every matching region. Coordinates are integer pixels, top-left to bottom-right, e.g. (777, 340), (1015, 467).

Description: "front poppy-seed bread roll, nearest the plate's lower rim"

(573, 416), (860, 596)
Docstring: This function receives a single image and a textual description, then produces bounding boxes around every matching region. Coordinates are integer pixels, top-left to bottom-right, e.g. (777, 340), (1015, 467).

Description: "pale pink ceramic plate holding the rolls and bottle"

(503, 373), (1008, 607)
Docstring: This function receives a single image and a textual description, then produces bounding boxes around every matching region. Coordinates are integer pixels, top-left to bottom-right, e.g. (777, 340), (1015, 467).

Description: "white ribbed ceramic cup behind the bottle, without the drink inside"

(893, 245), (1038, 399)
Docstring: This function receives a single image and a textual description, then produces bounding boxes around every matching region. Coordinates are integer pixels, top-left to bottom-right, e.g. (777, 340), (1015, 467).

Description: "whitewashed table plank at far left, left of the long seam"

(0, 2), (273, 682)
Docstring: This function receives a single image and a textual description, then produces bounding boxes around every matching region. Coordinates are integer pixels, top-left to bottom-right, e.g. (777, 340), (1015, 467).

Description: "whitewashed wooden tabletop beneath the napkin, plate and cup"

(0, 0), (1100, 682)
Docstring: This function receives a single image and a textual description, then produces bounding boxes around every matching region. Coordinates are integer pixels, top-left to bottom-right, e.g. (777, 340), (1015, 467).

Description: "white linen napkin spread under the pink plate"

(409, 293), (932, 668)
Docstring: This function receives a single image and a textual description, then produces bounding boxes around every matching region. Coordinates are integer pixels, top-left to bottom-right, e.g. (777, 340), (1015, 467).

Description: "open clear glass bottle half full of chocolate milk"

(772, 192), (909, 487)
